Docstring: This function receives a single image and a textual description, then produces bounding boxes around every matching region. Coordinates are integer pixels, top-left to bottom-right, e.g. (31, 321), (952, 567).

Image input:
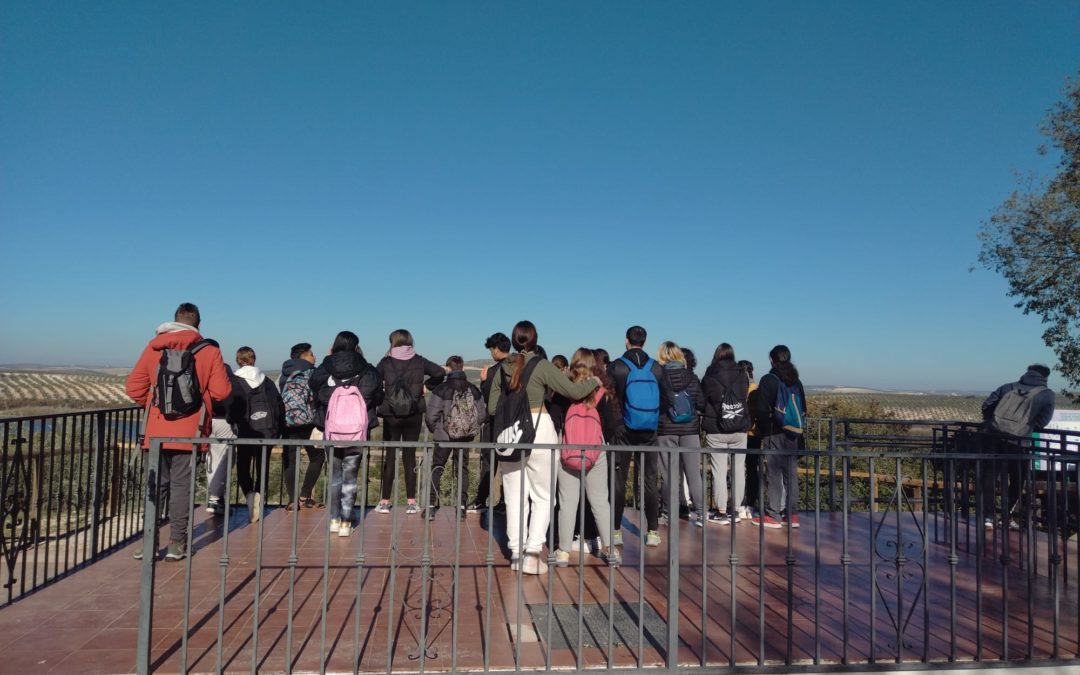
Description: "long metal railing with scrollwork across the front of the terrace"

(137, 420), (1080, 673)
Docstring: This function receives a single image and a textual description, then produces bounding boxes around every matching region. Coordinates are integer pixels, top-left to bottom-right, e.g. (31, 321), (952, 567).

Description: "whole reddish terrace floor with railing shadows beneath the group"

(0, 508), (1080, 673)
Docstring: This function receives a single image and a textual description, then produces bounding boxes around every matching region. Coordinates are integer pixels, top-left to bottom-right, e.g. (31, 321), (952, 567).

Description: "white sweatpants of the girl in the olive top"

(499, 413), (558, 557)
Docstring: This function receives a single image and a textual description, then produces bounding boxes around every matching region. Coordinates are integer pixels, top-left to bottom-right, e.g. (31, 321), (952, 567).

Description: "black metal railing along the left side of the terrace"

(0, 407), (145, 607)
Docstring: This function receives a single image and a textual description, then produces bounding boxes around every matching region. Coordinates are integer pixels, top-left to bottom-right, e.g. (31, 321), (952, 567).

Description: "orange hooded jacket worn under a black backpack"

(124, 324), (232, 453)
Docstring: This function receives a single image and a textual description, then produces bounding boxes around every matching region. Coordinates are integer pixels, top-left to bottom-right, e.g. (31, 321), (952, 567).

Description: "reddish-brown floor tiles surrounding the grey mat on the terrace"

(0, 510), (1077, 673)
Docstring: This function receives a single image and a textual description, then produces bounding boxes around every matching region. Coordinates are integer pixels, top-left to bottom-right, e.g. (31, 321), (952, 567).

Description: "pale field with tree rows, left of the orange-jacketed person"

(0, 370), (133, 416)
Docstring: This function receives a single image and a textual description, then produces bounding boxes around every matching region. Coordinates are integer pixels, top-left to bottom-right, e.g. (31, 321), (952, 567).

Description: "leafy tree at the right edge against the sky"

(978, 72), (1080, 389)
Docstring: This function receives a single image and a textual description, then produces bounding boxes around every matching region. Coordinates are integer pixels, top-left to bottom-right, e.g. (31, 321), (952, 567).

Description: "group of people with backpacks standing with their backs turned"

(126, 303), (1053, 573)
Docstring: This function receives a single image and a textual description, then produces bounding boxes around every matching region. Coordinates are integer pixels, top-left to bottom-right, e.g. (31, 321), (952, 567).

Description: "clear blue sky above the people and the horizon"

(0, 1), (1080, 390)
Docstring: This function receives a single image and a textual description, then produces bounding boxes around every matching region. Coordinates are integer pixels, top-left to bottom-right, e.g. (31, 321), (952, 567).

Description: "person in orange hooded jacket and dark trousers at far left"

(124, 302), (232, 561)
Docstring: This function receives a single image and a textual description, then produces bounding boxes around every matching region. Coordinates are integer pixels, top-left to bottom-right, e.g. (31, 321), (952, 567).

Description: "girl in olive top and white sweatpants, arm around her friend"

(488, 321), (599, 575)
